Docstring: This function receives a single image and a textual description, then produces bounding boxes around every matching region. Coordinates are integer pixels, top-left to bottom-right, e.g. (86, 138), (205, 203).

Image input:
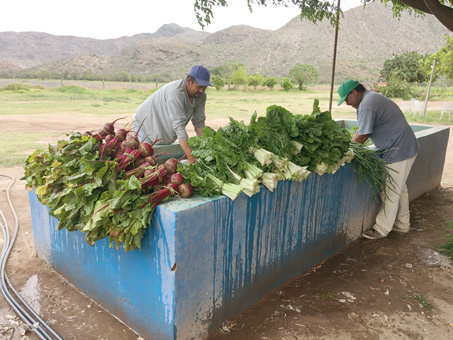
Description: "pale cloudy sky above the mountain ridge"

(0, 0), (360, 39)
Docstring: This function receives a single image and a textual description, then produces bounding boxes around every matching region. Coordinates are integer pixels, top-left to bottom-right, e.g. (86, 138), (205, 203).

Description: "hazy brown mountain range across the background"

(0, 2), (451, 82)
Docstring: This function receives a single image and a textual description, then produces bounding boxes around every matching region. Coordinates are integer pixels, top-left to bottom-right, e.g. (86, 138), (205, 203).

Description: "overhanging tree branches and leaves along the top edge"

(194, 0), (453, 32)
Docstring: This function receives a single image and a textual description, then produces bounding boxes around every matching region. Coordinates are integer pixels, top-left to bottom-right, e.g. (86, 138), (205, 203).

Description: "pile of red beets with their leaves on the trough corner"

(23, 122), (192, 251)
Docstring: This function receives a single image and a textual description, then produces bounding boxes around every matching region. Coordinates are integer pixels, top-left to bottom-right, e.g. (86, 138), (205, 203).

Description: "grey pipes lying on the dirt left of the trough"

(0, 174), (63, 340)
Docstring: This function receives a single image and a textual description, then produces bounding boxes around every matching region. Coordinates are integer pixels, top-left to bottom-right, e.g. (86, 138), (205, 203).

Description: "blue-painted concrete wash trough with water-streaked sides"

(29, 121), (449, 340)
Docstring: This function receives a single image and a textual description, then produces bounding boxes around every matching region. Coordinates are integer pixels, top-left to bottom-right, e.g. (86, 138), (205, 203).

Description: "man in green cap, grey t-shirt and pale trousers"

(338, 79), (420, 239)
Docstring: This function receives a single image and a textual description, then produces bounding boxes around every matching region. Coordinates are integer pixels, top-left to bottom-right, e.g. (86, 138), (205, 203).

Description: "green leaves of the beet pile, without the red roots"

(23, 133), (153, 251)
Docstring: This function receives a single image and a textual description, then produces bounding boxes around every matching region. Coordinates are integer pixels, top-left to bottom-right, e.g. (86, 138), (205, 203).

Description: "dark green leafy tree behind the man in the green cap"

(381, 51), (430, 83)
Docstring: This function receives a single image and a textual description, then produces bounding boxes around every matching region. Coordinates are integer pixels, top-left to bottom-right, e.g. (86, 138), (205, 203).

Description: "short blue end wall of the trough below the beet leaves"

(29, 192), (175, 339)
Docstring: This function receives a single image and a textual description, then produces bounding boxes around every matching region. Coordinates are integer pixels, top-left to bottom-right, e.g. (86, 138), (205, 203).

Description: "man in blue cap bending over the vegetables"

(134, 65), (212, 163)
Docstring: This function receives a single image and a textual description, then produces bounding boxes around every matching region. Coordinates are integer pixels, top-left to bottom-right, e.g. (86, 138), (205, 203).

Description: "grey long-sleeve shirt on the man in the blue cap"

(134, 78), (206, 144)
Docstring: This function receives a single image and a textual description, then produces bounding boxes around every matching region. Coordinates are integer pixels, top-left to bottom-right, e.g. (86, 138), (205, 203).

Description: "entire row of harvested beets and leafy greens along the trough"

(22, 100), (389, 251)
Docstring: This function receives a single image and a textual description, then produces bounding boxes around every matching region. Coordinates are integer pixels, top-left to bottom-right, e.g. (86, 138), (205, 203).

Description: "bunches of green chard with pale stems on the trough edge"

(178, 100), (354, 200)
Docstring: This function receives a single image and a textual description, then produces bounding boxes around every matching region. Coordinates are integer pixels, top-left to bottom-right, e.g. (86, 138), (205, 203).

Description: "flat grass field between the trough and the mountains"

(0, 80), (453, 166)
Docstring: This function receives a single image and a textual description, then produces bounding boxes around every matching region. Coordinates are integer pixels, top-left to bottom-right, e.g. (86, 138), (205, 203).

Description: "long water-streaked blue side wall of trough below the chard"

(170, 165), (371, 339)
